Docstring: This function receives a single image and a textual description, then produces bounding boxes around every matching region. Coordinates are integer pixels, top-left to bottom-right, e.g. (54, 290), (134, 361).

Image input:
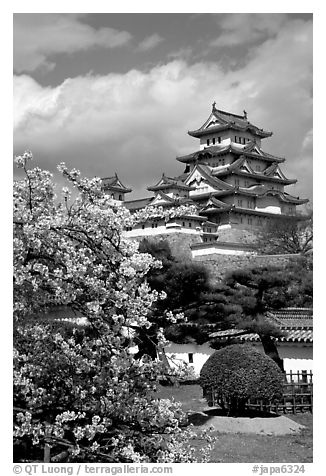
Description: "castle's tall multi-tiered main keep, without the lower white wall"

(126, 103), (308, 238)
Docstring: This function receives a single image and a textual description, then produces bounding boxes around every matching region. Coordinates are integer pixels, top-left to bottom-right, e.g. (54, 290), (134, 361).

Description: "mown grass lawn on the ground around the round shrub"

(157, 385), (313, 463)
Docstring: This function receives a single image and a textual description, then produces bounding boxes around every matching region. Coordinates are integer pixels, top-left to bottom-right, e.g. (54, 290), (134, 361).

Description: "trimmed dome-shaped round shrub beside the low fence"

(199, 344), (283, 412)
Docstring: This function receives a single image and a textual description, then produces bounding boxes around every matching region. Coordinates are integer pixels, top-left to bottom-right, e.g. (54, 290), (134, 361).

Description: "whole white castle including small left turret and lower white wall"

(104, 102), (308, 253)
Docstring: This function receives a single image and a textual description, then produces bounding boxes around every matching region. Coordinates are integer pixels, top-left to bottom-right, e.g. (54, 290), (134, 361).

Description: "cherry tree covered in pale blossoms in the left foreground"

(14, 152), (209, 462)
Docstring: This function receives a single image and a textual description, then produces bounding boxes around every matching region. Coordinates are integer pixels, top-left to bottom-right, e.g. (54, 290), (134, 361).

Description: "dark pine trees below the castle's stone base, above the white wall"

(141, 240), (312, 369)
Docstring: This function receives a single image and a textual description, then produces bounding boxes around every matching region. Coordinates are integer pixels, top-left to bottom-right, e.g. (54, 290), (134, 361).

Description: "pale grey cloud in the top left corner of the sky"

(14, 13), (131, 73)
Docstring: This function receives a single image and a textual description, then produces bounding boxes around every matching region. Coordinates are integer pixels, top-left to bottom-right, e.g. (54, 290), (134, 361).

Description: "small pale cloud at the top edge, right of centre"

(211, 13), (287, 47)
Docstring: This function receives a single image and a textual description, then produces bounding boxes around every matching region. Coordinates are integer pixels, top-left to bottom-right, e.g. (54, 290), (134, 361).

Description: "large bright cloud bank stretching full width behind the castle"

(14, 20), (312, 201)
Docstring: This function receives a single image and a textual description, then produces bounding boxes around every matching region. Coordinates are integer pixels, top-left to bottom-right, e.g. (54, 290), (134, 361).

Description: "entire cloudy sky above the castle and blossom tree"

(14, 13), (312, 203)
